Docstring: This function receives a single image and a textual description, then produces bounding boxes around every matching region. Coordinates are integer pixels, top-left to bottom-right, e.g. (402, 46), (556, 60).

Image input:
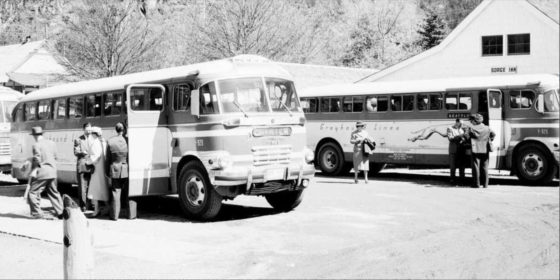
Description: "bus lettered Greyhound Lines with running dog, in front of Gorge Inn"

(300, 74), (559, 184)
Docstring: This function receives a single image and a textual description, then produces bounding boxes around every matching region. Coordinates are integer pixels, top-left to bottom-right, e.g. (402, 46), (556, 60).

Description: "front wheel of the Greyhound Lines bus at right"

(515, 146), (557, 185)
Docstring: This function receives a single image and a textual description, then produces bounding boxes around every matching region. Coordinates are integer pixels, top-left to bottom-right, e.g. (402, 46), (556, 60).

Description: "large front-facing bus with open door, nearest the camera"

(11, 55), (315, 220)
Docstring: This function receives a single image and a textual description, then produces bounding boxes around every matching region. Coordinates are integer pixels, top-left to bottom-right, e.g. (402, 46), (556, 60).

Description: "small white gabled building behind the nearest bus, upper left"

(0, 41), (77, 93)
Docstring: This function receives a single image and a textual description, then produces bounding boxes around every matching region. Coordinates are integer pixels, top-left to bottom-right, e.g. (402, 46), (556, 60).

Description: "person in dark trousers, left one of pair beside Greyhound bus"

(447, 119), (465, 184)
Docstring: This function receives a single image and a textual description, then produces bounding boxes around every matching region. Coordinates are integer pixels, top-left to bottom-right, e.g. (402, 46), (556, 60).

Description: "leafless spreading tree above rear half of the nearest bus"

(56, 0), (157, 78)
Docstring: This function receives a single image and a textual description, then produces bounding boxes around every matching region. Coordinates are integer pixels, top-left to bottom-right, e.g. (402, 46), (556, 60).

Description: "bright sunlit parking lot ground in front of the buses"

(0, 170), (559, 279)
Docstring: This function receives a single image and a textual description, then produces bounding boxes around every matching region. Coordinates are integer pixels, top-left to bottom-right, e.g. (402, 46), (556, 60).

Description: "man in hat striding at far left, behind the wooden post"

(28, 126), (63, 219)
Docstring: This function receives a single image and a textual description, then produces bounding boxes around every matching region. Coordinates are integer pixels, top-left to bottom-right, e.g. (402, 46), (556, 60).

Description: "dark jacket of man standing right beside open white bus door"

(105, 135), (128, 179)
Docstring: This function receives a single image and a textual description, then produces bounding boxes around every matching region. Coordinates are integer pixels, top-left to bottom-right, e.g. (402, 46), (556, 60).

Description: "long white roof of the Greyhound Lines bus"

(299, 74), (559, 97)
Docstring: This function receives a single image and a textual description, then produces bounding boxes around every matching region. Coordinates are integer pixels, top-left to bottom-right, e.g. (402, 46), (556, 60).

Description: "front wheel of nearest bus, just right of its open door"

(177, 162), (222, 220)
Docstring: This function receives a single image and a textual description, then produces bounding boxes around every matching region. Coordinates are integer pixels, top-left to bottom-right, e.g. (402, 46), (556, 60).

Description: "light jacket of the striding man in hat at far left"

(32, 138), (56, 180)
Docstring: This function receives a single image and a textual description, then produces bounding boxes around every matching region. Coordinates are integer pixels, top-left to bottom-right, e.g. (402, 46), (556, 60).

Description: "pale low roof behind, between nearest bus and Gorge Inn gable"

(278, 62), (379, 88)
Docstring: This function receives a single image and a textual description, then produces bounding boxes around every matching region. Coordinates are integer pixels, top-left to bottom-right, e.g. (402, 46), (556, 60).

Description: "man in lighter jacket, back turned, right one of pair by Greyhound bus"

(468, 114), (496, 188)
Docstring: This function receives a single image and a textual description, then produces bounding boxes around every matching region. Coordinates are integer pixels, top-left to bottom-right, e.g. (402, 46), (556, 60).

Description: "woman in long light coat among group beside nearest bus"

(87, 126), (109, 217)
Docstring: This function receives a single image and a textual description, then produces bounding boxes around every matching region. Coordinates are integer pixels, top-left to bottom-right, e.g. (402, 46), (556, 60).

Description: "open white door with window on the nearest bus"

(126, 84), (171, 196)
